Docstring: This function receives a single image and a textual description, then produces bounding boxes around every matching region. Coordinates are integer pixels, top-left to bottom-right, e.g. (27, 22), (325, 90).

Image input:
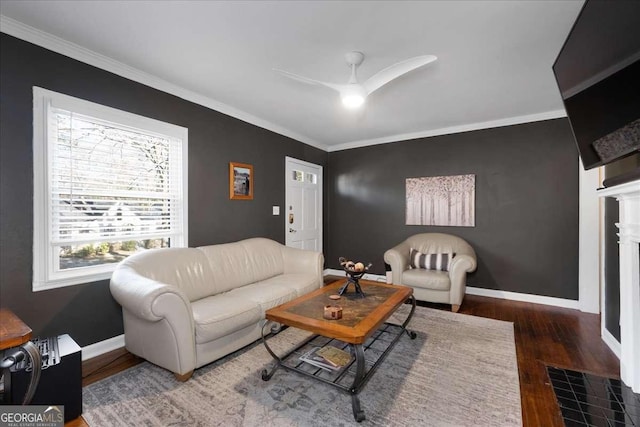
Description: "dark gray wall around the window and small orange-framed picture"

(0, 34), (328, 346)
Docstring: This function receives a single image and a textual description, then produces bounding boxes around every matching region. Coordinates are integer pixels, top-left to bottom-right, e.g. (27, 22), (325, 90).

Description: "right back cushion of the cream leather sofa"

(197, 238), (284, 294)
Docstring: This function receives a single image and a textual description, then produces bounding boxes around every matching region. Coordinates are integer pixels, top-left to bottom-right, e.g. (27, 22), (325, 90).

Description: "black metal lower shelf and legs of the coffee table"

(262, 297), (416, 422)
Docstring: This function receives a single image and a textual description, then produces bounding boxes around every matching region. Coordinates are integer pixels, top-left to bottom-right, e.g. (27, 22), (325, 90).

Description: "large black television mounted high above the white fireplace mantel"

(553, 0), (640, 169)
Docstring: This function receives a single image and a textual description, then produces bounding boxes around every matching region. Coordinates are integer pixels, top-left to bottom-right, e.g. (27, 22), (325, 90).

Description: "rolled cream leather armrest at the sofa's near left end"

(109, 266), (193, 323)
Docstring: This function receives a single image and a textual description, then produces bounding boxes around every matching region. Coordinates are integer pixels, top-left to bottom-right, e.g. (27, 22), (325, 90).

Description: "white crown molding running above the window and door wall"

(0, 15), (327, 151)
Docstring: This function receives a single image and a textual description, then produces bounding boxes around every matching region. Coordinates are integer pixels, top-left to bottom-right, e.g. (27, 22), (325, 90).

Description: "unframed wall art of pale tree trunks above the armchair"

(406, 175), (476, 227)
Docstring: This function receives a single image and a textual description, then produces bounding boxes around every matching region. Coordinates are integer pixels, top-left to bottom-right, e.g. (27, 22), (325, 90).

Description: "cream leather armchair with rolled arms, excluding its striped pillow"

(384, 233), (476, 312)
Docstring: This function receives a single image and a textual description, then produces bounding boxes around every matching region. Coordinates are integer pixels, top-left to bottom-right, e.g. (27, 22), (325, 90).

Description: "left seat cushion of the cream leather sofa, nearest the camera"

(191, 294), (262, 344)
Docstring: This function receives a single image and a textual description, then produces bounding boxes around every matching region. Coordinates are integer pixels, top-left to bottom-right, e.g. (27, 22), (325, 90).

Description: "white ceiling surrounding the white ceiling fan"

(0, 0), (583, 151)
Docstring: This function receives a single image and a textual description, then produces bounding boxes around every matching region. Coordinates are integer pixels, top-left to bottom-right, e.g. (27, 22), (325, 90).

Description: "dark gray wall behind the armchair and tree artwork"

(325, 119), (579, 300)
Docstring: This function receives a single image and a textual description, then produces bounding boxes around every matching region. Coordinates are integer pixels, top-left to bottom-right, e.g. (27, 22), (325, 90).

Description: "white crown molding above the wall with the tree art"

(328, 110), (567, 152)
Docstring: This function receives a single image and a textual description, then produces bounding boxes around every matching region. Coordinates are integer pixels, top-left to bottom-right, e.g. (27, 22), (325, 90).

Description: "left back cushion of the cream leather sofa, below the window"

(122, 248), (213, 301)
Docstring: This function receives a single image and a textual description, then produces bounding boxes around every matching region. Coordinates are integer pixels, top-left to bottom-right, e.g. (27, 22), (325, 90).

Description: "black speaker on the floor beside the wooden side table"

(10, 334), (82, 422)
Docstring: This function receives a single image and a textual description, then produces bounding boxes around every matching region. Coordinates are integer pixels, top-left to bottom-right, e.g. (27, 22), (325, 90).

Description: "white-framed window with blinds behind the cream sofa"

(33, 87), (187, 291)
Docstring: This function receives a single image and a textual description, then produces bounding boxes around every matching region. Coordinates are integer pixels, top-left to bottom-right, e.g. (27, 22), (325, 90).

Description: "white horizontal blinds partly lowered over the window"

(49, 107), (183, 245)
